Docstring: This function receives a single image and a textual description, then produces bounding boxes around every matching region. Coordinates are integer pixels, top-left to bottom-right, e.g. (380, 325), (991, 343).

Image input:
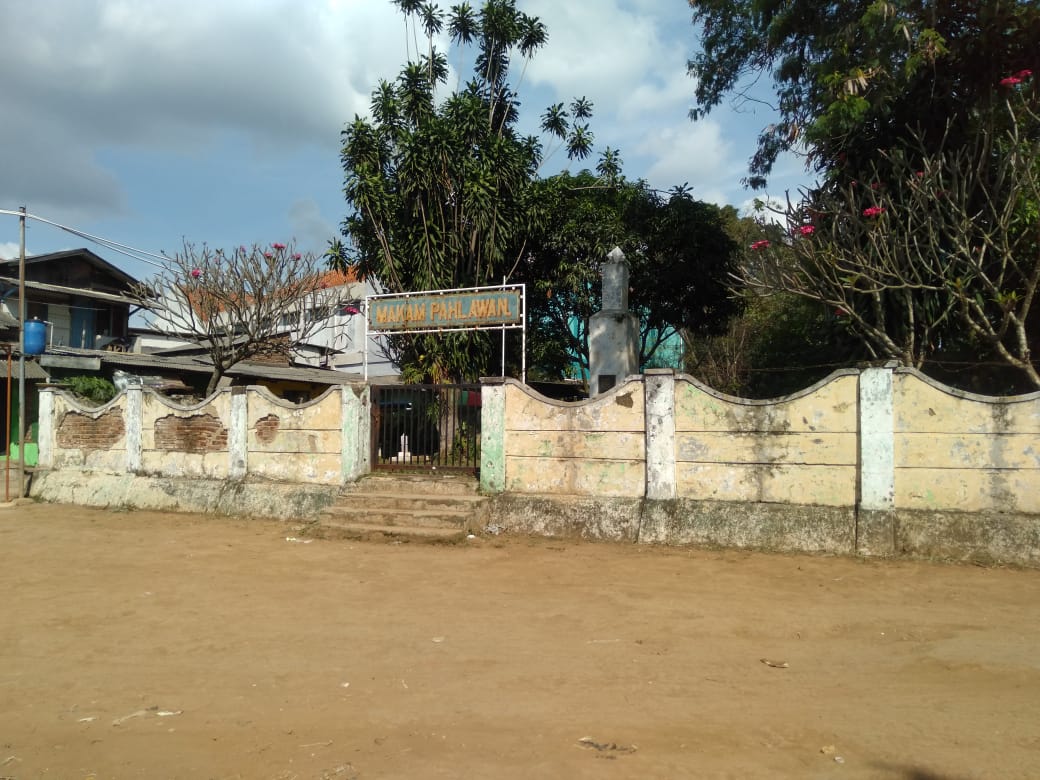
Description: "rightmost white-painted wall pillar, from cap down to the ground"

(856, 363), (895, 555)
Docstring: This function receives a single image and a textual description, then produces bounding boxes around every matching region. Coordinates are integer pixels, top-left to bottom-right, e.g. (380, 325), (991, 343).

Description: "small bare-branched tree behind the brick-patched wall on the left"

(132, 243), (339, 395)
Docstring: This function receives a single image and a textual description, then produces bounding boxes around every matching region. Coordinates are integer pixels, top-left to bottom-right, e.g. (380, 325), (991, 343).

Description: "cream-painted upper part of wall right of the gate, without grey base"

(482, 367), (1040, 514)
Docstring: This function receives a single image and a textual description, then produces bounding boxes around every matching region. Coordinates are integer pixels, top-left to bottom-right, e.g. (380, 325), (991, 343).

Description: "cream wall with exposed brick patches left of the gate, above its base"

(40, 386), (369, 486)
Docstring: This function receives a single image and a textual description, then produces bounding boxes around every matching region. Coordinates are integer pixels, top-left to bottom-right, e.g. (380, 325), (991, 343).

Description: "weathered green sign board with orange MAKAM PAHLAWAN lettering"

(368, 287), (523, 333)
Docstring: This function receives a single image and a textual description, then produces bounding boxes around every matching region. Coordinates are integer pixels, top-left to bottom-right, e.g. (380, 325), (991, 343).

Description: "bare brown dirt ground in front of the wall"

(0, 505), (1040, 780)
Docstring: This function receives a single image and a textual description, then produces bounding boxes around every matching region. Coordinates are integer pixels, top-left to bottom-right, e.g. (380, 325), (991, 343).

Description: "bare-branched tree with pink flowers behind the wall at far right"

(739, 94), (1040, 388)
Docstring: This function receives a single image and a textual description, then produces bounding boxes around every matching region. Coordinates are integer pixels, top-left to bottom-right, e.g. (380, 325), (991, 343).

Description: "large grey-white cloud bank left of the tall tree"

(0, 0), (400, 218)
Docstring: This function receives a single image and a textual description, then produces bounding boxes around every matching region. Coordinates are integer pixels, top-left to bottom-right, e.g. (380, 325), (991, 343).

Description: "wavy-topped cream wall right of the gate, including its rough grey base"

(482, 365), (1040, 566)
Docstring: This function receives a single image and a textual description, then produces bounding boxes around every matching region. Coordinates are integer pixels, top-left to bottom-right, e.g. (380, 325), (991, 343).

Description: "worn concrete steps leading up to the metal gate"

(307, 472), (487, 543)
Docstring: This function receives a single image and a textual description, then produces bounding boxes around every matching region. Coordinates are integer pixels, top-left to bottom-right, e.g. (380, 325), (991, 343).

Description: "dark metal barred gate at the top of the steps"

(371, 385), (480, 473)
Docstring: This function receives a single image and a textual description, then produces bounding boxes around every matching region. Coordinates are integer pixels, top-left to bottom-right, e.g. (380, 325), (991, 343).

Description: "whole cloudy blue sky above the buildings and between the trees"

(0, 0), (808, 279)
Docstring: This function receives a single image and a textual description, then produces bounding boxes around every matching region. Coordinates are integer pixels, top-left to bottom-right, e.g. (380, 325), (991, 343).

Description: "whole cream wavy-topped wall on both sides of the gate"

(32, 366), (1040, 566)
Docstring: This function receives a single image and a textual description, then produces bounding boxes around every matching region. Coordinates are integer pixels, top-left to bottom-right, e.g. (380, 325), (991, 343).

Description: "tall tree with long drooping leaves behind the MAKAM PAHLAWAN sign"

(330, 0), (593, 381)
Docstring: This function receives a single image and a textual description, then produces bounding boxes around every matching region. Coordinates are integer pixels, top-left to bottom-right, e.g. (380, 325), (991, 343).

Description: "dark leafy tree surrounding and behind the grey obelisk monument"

(518, 169), (738, 376)
